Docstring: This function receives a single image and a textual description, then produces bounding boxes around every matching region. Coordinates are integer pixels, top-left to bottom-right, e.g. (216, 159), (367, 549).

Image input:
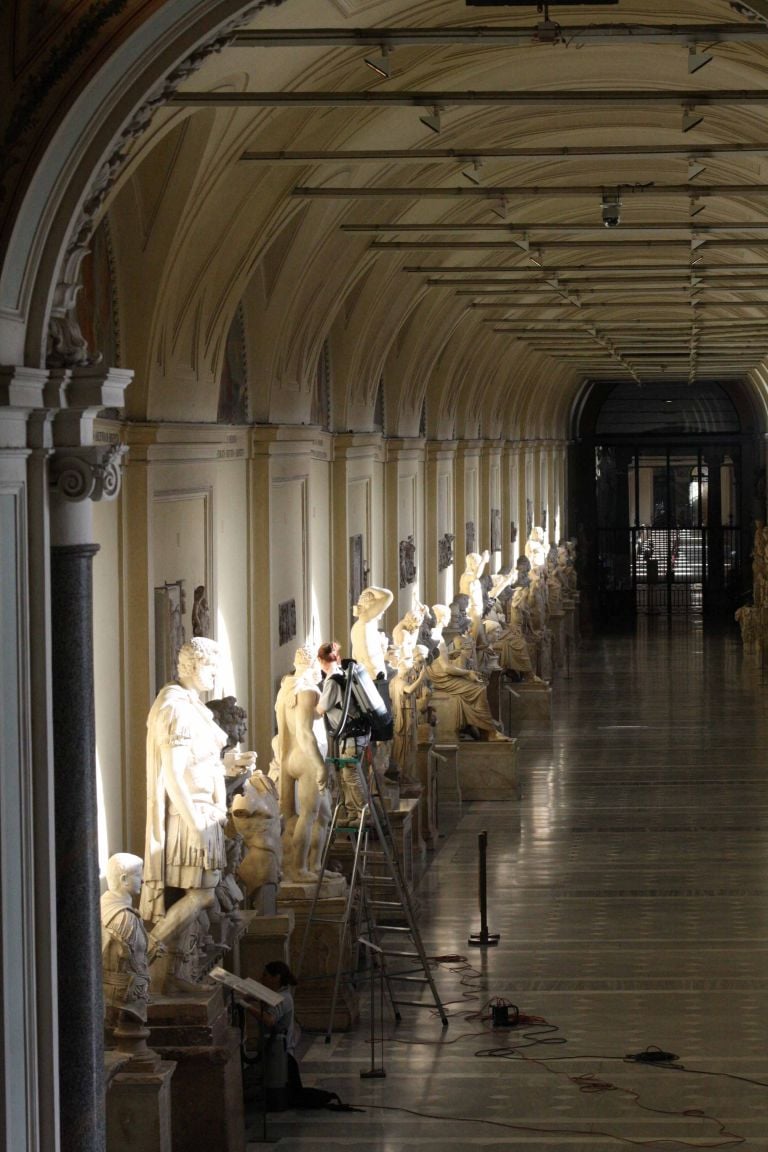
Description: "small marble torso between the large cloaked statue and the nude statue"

(231, 771), (282, 911)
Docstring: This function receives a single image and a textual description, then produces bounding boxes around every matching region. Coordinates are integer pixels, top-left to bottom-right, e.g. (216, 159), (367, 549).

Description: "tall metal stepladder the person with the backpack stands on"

(298, 741), (448, 1043)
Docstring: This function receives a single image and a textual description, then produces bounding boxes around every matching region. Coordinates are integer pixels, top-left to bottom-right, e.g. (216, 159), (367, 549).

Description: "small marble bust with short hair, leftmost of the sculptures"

(100, 852), (154, 1026)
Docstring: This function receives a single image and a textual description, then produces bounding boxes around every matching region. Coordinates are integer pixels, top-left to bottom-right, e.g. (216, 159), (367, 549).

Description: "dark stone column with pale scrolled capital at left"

(46, 367), (131, 1152)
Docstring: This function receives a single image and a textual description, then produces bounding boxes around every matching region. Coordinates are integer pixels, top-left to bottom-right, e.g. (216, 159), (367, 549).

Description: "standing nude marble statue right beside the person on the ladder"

(274, 646), (328, 882)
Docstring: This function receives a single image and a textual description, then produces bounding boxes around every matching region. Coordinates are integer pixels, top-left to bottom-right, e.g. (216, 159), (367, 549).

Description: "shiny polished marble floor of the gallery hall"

(249, 621), (768, 1152)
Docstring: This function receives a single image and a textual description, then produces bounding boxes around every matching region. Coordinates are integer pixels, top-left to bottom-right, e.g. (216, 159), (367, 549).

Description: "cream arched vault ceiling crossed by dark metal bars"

(111, 0), (768, 439)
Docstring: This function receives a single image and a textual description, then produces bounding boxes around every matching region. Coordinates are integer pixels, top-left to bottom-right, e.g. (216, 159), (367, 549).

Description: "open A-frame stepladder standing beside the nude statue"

(298, 745), (448, 1044)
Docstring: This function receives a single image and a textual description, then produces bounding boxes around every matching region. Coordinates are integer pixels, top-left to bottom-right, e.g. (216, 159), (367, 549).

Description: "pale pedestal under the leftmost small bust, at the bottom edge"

(106, 1060), (176, 1152)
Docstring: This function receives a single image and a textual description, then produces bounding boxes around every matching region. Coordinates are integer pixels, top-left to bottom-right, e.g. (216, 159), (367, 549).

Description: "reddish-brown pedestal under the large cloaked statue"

(147, 986), (245, 1152)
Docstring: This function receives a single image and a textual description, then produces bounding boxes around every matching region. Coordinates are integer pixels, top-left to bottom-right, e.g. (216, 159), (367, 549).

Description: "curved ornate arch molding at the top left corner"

(0, 0), (283, 367)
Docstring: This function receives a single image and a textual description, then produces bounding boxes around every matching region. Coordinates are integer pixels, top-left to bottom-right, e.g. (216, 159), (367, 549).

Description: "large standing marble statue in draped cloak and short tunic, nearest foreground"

(140, 636), (227, 992)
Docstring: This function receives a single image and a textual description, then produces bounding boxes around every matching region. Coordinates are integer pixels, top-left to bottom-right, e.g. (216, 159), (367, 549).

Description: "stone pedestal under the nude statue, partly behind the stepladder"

(277, 877), (359, 1032)
